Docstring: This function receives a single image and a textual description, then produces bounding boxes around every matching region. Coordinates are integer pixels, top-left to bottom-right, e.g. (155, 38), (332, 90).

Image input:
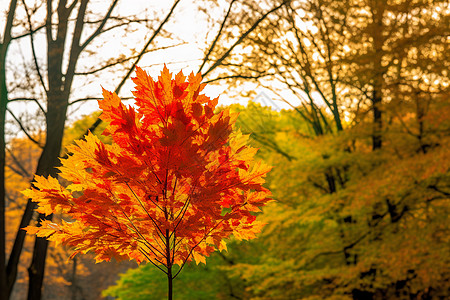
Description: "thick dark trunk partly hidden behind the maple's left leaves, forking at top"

(28, 0), (72, 300)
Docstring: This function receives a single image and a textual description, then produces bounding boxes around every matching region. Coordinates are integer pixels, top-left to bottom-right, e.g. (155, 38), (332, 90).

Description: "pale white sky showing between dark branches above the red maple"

(0, 0), (298, 138)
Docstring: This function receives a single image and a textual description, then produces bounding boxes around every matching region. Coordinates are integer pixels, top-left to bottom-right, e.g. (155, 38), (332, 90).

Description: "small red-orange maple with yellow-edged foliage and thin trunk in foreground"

(24, 67), (270, 299)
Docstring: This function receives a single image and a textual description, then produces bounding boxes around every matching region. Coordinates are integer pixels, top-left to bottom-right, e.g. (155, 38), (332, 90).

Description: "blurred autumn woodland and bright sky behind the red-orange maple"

(0, 0), (450, 300)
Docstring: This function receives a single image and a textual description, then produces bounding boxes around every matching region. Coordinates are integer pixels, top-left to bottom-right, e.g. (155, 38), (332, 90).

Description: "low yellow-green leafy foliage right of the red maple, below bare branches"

(103, 78), (450, 299)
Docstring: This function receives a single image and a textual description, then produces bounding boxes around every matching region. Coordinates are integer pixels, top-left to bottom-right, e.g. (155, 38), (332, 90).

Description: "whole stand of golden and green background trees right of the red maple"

(96, 0), (450, 299)
